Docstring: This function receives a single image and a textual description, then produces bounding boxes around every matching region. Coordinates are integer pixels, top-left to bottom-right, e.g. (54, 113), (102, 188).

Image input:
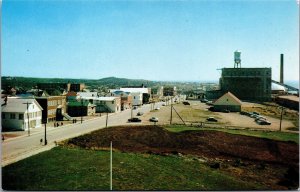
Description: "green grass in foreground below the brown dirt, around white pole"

(2, 147), (266, 191)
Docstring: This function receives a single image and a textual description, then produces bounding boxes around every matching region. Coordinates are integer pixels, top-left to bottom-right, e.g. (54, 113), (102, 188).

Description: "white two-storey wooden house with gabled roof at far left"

(1, 97), (43, 131)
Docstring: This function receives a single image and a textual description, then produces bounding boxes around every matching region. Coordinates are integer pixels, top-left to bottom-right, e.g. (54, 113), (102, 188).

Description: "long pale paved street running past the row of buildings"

(2, 103), (161, 166)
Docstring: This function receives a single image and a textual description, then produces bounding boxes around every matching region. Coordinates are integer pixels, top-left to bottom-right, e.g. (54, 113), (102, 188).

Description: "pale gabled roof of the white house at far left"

(2, 97), (43, 113)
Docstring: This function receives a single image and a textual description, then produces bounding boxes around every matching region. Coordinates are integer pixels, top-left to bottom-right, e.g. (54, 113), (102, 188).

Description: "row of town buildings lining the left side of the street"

(1, 83), (175, 130)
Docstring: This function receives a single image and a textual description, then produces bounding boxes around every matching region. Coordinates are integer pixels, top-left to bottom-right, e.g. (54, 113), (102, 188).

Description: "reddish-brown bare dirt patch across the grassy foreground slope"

(65, 126), (299, 189)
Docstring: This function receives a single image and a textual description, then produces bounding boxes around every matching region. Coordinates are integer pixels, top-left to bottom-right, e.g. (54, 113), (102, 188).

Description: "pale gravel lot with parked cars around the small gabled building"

(141, 101), (295, 131)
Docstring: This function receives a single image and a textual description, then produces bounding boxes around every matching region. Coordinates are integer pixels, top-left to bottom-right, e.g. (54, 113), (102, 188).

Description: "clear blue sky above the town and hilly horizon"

(1, 0), (299, 81)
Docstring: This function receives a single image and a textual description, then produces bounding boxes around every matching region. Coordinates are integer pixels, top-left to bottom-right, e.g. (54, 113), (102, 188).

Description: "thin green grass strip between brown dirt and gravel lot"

(165, 125), (299, 144)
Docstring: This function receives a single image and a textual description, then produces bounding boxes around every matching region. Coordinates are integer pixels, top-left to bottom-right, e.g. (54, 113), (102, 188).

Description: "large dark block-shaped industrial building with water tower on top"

(206, 51), (272, 101)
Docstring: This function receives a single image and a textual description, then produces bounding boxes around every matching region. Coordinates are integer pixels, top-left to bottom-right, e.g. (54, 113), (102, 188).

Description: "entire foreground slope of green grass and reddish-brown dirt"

(2, 125), (299, 191)
